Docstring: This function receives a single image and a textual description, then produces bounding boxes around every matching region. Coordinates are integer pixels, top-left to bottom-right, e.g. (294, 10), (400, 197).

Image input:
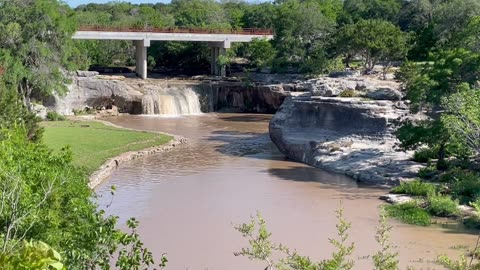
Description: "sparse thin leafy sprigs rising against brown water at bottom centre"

(234, 206), (398, 270)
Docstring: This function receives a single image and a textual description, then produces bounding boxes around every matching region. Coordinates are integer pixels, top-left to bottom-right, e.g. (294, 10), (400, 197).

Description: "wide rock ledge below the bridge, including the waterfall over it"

(50, 74), (288, 115)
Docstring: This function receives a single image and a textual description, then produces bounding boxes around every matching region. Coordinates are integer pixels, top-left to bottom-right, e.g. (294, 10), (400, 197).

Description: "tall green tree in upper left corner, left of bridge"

(0, 0), (81, 107)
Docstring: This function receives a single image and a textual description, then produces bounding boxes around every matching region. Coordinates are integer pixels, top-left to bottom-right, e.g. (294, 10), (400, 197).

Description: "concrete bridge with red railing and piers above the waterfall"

(73, 26), (273, 79)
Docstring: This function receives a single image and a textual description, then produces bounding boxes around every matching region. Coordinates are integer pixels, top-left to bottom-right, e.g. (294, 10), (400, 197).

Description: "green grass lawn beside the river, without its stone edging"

(42, 121), (172, 173)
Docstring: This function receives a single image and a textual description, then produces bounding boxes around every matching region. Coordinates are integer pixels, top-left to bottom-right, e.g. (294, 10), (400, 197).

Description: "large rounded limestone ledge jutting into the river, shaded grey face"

(269, 96), (422, 186)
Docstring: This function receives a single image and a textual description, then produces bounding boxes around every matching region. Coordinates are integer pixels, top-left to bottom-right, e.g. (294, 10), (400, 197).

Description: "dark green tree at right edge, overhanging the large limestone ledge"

(397, 49), (480, 169)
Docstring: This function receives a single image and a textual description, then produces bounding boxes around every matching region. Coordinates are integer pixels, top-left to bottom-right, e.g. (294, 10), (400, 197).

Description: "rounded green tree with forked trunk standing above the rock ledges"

(337, 20), (408, 77)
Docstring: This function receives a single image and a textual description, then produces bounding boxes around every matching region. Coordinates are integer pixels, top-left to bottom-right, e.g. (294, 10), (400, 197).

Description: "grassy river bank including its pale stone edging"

(42, 117), (186, 189)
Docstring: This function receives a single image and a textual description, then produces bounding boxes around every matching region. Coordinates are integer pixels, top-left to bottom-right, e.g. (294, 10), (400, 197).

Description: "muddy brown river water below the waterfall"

(97, 114), (476, 270)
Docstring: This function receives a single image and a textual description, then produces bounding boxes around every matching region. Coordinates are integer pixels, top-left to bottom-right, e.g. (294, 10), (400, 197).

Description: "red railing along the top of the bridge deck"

(78, 25), (273, 36)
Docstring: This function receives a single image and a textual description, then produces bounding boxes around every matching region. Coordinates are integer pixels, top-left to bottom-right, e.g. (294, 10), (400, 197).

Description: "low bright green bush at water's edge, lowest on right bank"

(385, 202), (431, 226)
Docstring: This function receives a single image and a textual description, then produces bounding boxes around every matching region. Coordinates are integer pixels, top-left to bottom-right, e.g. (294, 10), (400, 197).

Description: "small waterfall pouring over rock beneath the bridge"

(142, 86), (201, 116)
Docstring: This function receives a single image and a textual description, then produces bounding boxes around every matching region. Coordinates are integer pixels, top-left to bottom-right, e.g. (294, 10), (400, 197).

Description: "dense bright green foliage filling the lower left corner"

(0, 127), (166, 270)
